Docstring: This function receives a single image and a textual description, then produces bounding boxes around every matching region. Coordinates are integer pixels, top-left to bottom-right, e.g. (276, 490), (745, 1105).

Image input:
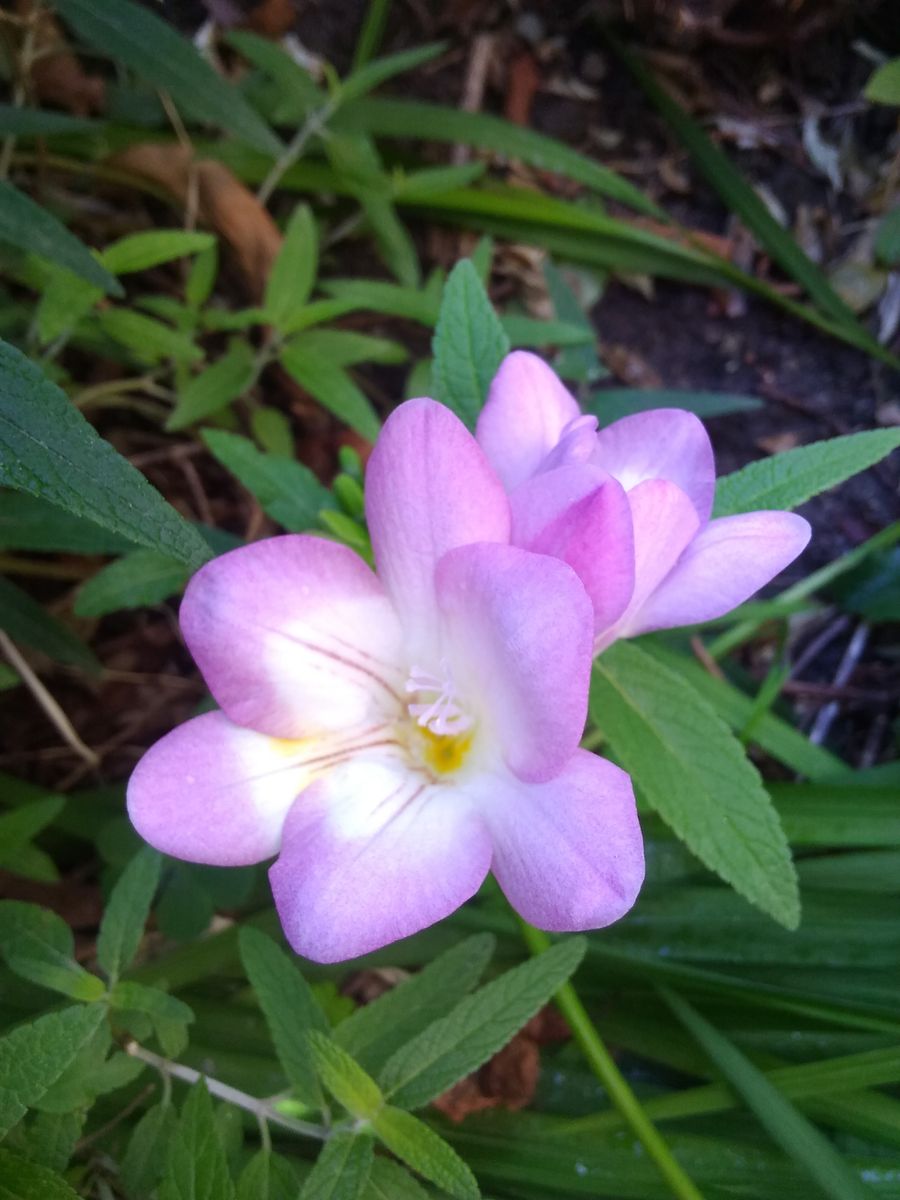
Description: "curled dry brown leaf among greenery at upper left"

(114, 142), (282, 300)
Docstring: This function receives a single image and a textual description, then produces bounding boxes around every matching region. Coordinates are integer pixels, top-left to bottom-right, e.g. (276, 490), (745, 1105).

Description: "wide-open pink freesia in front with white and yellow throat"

(128, 400), (643, 962)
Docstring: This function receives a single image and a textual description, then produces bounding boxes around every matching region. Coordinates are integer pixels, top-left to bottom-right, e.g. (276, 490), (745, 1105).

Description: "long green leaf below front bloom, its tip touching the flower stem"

(378, 937), (584, 1109)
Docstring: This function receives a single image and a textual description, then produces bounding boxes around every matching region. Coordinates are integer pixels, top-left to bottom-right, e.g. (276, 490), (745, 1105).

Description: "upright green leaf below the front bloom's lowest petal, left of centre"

(239, 928), (328, 1106)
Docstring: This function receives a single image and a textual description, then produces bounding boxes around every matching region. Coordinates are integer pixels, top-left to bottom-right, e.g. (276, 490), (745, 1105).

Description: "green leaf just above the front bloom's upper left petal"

(202, 430), (335, 533)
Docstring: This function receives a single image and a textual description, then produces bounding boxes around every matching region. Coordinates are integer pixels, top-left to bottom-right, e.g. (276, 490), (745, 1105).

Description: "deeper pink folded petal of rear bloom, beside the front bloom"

(510, 464), (635, 631)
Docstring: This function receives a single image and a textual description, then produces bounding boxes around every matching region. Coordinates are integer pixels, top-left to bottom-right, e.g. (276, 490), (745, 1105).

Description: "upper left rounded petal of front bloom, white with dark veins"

(180, 534), (402, 738)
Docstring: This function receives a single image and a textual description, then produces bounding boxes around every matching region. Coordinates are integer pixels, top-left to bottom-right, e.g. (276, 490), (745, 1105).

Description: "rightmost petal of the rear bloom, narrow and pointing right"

(631, 512), (810, 634)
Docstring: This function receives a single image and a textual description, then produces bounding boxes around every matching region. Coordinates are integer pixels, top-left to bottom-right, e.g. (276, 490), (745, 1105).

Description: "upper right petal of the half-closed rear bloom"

(594, 408), (715, 521)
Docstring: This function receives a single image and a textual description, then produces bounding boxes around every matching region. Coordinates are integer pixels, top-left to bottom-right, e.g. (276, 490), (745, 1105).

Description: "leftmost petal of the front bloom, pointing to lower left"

(128, 713), (316, 866)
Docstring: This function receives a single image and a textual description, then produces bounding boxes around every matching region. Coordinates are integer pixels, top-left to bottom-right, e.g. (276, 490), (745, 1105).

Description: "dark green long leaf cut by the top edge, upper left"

(56, 0), (283, 155)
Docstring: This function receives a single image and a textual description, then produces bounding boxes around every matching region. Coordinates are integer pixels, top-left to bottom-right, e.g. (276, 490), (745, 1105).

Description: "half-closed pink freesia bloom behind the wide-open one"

(476, 350), (810, 653)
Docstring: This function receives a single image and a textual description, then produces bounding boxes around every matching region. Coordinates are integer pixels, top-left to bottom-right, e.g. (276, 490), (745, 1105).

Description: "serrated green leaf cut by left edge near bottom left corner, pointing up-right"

(0, 1004), (106, 1138)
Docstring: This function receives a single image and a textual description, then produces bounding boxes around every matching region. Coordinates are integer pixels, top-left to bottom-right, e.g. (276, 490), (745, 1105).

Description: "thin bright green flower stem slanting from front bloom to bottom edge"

(520, 919), (703, 1200)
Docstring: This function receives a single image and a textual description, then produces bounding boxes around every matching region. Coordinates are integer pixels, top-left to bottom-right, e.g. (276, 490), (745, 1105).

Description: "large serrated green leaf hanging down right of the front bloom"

(590, 642), (800, 929)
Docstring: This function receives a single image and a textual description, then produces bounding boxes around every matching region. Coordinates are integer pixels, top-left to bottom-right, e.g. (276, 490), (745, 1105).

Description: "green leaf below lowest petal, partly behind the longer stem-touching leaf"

(334, 934), (496, 1072)
